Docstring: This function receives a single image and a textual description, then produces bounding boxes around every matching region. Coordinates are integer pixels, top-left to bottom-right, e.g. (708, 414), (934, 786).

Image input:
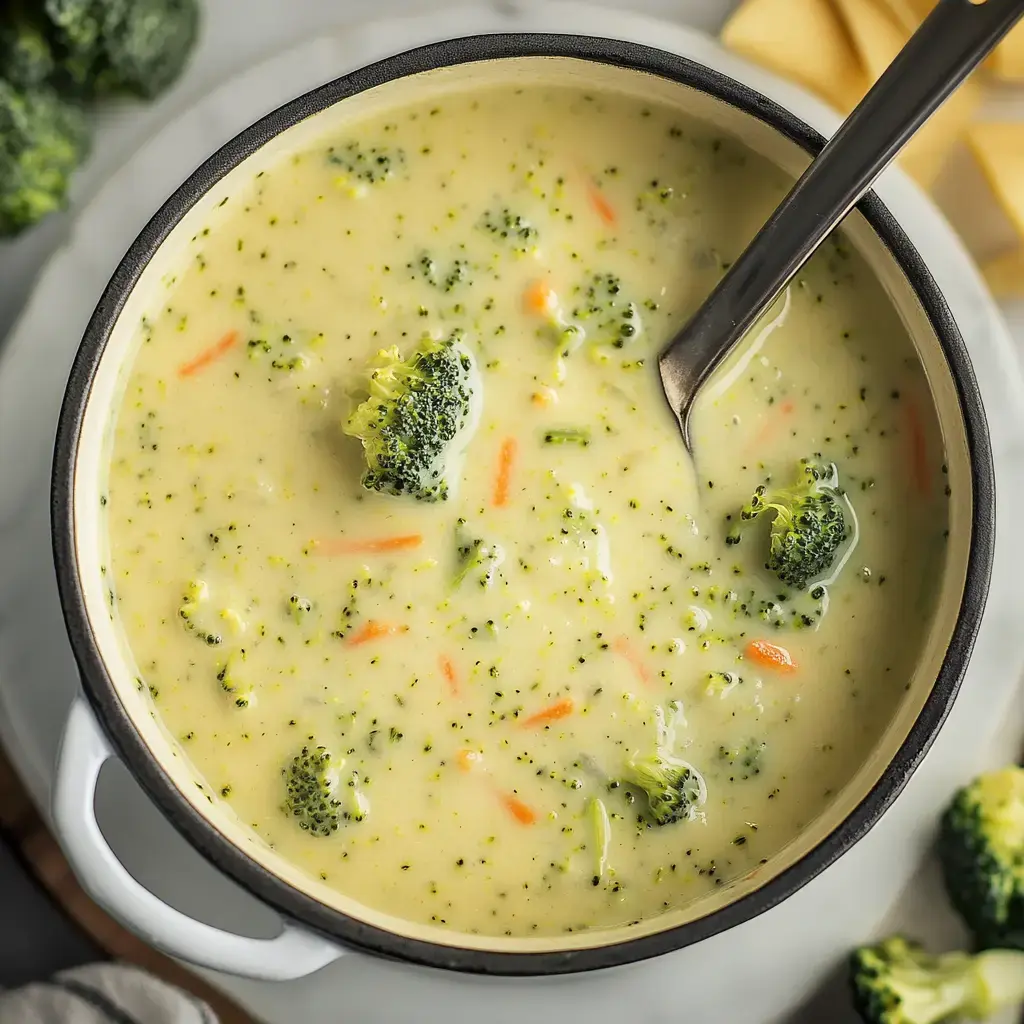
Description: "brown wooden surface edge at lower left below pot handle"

(0, 751), (257, 1024)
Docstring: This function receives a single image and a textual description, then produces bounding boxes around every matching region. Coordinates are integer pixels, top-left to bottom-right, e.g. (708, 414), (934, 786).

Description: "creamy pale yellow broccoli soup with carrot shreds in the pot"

(103, 86), (947, 936)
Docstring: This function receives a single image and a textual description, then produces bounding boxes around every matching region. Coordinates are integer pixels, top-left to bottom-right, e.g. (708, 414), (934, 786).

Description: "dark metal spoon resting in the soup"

(658, 0), (1024, 451)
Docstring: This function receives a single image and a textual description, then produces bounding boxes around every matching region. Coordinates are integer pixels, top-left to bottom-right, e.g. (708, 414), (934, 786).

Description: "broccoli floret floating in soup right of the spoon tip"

(726, 459), (850, 590)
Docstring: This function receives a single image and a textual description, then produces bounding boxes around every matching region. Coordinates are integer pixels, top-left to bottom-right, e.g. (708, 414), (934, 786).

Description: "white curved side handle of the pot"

(53, 696), (345, 981)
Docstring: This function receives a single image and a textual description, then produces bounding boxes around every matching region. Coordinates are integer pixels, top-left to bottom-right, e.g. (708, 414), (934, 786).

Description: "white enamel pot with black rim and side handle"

(52, 34), (994, 979)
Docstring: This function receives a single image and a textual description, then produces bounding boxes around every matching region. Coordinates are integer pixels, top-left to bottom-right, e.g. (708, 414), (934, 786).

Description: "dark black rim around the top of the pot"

(50, 33), (995, 975)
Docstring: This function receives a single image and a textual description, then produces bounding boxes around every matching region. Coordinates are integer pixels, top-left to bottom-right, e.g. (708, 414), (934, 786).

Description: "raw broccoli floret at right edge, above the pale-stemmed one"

(939, 766), (1024, 949)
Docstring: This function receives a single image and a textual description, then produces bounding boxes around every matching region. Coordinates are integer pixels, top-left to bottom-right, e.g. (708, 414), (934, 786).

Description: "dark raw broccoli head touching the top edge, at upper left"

(45, 0), (200, 99)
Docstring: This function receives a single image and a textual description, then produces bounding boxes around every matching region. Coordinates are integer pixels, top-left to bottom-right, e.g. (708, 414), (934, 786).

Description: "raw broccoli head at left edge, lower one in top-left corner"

(0, 80), (89, 237)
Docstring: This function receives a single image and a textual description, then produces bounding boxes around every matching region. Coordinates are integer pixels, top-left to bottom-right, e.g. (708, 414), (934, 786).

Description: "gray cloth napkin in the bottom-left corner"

(0, 964), (217, 1024)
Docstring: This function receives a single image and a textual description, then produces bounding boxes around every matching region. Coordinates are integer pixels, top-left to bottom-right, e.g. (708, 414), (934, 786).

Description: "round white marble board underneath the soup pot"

(0, 2), (1024, 1024)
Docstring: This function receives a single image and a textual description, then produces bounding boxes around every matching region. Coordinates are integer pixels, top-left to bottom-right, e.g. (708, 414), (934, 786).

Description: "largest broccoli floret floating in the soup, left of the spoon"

(344, 335), (480, 502)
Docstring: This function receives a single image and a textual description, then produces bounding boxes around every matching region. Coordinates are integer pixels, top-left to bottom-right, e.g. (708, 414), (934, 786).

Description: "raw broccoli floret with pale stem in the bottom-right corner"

(850, 936), (1024, 1024)
